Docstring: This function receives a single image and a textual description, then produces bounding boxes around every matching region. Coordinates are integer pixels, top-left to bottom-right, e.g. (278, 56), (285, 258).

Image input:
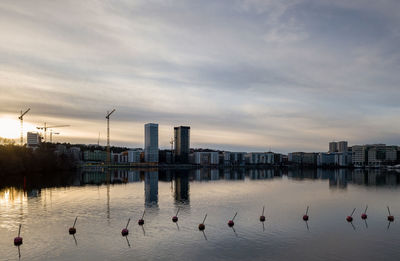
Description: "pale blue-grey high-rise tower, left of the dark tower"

(144, 123), (158, 162)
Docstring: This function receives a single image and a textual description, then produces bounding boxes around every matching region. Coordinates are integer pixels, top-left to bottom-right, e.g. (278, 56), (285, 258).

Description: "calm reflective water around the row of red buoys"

(0, 167), (400, 260)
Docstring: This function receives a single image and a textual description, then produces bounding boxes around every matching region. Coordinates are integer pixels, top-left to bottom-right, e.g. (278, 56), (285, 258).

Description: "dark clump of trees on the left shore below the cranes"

(0, 144), (74, 178)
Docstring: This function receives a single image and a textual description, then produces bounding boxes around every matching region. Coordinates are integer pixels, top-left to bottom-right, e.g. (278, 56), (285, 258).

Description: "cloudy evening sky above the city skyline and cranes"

(0, 0), (400, 153)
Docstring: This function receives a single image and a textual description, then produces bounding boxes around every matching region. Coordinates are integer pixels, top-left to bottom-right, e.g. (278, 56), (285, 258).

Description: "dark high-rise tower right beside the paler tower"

(174, 126), (190, 163)
